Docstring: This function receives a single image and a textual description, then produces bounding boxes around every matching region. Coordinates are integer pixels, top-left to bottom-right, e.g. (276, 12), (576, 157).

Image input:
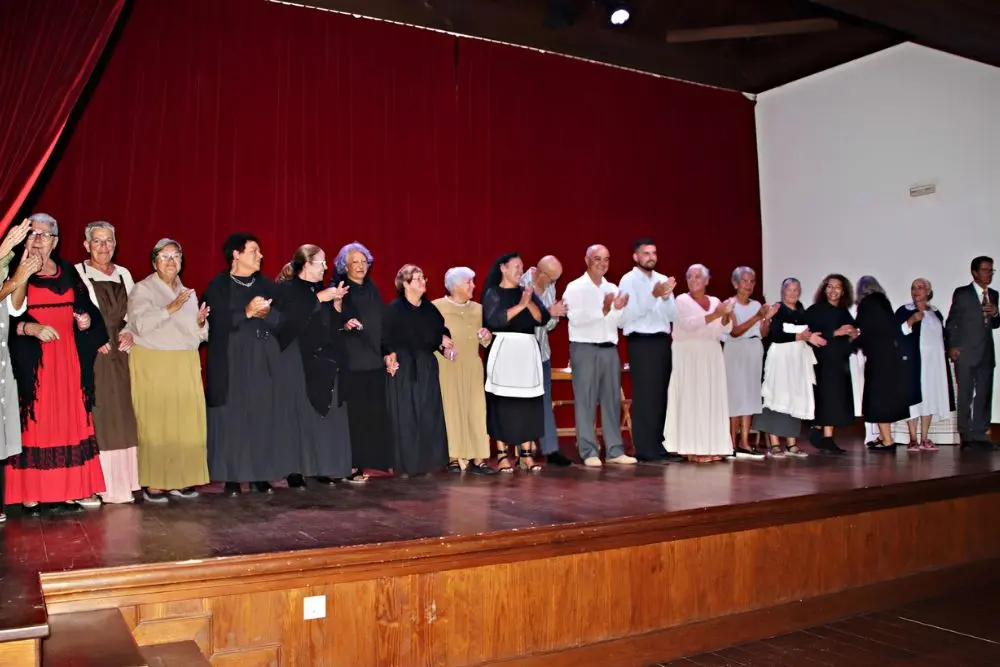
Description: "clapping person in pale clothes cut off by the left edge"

(0, 220), (36, 523)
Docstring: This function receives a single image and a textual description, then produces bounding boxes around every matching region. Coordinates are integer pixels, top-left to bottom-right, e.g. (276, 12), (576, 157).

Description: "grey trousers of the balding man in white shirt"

(569, 342), (625, 459)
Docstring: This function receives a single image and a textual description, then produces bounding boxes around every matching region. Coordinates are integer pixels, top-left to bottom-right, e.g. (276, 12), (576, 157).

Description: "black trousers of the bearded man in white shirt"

(627, 334), (672, 460)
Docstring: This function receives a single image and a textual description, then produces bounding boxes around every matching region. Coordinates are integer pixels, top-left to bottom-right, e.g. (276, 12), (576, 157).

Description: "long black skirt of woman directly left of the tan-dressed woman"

(386, 352), (448, 475)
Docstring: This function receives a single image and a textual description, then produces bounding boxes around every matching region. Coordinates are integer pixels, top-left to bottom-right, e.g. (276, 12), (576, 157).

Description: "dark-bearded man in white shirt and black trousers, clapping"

(618, 238), (682, 462)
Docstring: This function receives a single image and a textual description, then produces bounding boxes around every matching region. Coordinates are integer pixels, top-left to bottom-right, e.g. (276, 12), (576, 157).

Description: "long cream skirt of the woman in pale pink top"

(664, 339), (733, 456)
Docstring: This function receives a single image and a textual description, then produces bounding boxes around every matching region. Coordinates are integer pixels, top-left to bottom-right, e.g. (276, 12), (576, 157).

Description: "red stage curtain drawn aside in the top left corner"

(0, 0), (125, 230)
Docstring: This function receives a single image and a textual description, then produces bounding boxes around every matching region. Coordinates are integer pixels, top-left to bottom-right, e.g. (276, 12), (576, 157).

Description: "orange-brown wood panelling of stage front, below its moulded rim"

(39, 493), (1000, 667)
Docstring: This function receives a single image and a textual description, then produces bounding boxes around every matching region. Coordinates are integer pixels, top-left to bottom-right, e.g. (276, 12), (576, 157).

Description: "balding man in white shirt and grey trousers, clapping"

(563, 245), (636, 468)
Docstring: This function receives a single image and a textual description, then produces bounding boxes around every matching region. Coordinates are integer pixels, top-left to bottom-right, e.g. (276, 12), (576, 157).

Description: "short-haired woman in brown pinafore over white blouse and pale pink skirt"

(74, 221), (139, 503)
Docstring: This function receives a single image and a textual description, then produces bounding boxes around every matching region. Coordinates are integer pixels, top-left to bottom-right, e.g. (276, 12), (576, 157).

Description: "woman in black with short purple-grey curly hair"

(332, 242), (395, 483)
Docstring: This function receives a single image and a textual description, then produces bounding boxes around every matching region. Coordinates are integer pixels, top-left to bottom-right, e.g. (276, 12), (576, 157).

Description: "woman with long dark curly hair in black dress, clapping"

(806, 273), (858, 454)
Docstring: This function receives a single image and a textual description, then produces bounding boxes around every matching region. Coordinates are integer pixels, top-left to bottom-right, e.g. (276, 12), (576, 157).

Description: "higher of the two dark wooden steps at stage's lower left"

(42, 609), (147, 667)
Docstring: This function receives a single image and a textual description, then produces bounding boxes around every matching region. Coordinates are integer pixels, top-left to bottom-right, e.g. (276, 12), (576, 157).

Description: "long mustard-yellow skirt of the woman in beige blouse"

(129, 345), (209, 491)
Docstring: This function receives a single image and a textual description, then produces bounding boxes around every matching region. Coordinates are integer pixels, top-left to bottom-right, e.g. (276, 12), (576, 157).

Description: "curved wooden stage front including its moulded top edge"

(27, 473), (1000, 667)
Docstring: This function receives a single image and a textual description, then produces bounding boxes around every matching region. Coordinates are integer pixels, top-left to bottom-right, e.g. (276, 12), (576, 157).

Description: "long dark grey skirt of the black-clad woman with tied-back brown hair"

(278, 341), (351, 477)
